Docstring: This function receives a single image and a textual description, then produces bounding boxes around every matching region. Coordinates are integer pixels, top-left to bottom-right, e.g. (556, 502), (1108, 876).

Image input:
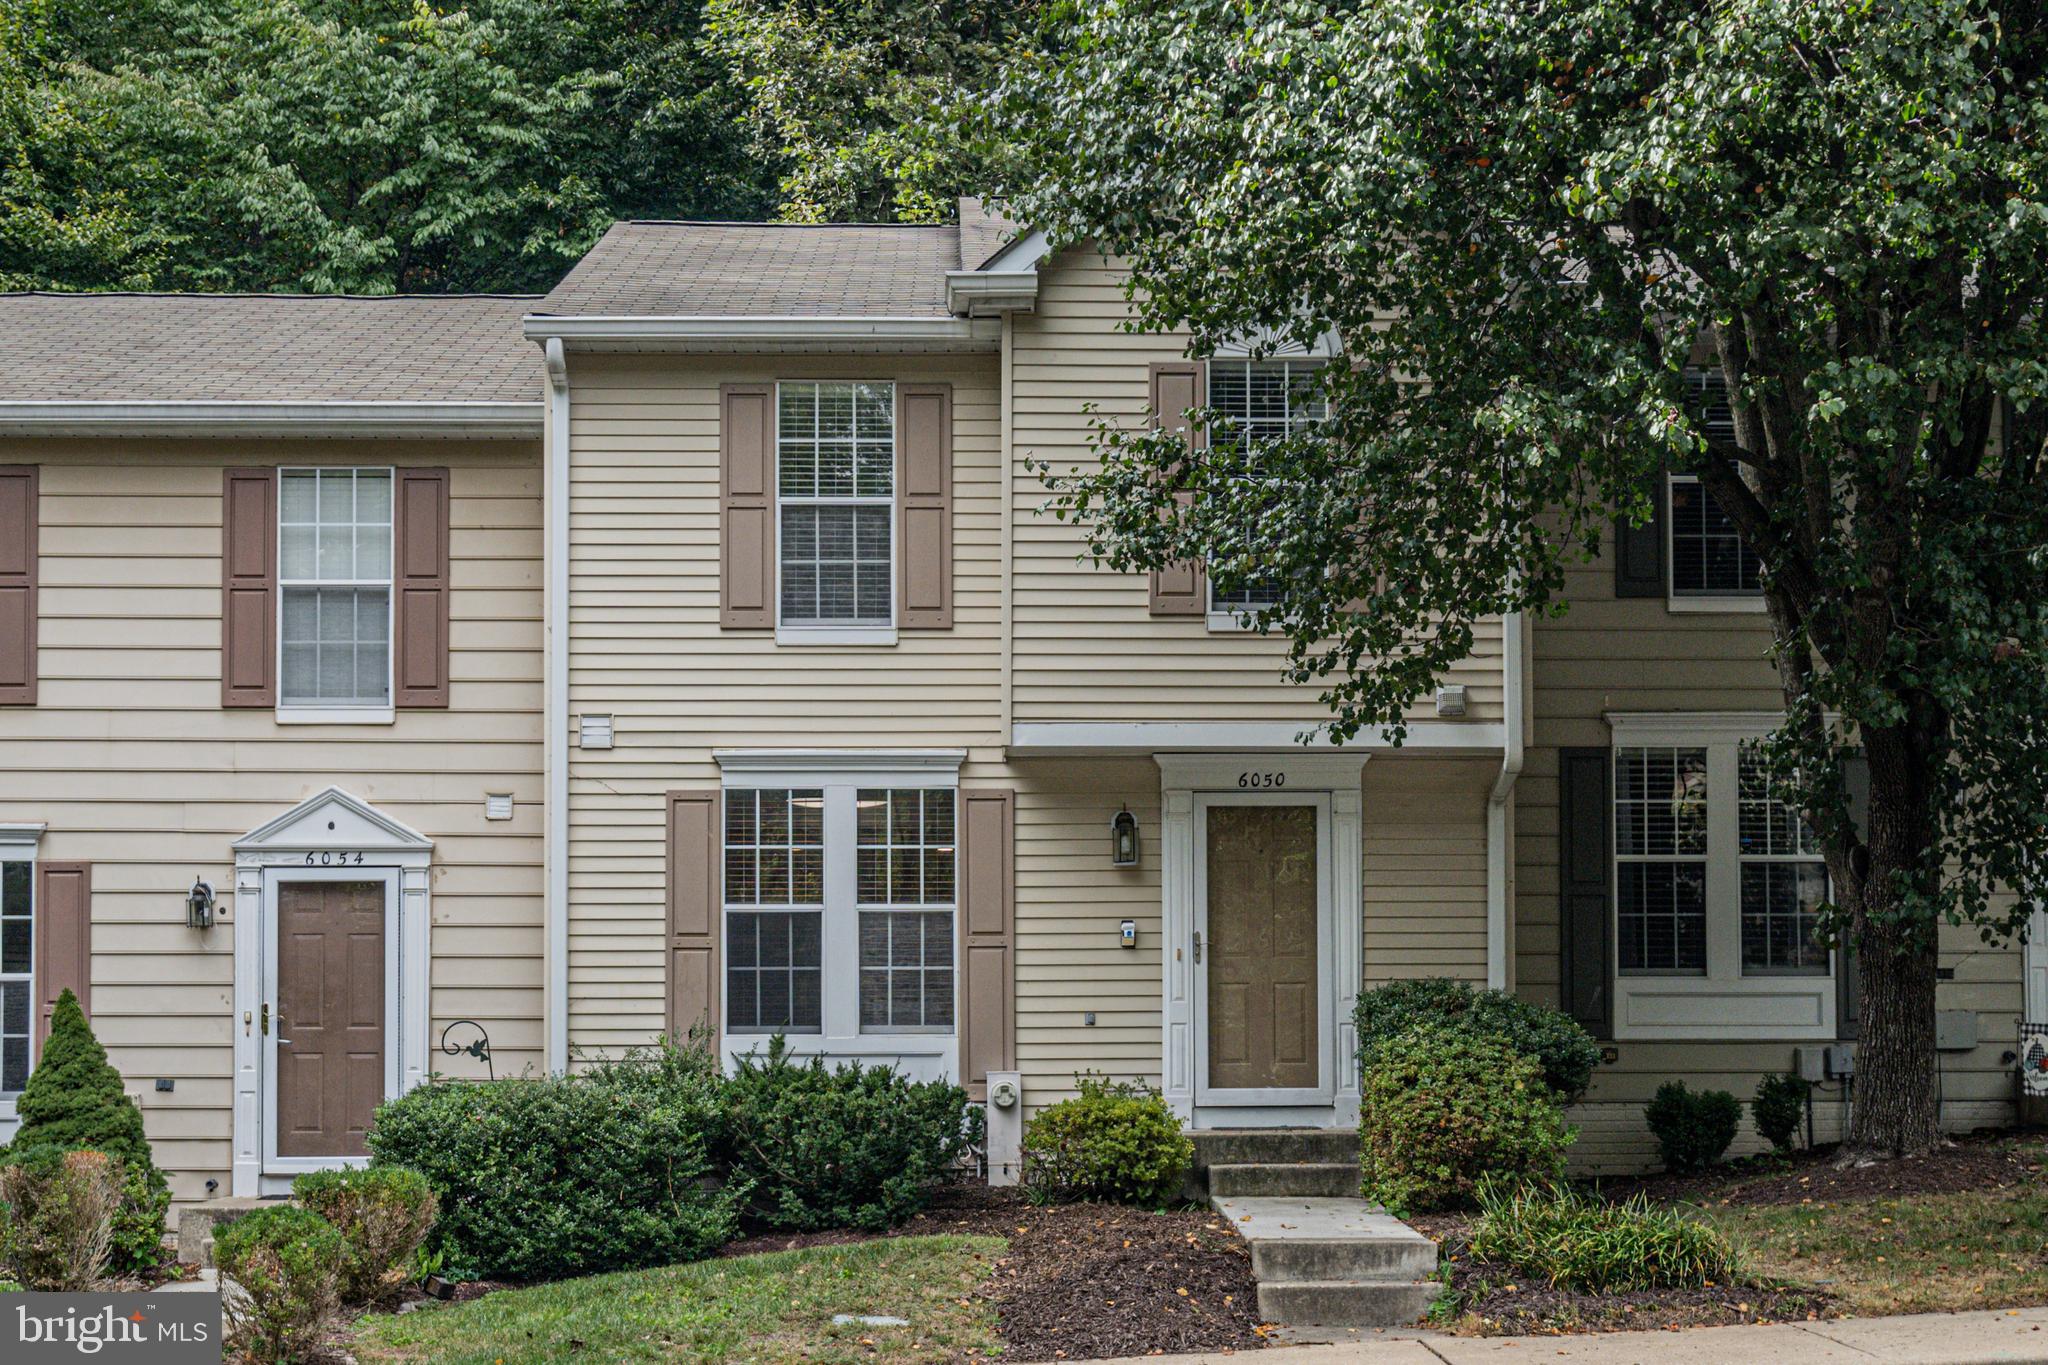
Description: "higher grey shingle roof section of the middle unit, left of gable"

(532, 223), (961, 317)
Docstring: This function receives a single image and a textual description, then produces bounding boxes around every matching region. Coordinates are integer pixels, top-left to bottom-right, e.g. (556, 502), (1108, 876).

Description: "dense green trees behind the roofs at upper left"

(0, 0), (1032, 293)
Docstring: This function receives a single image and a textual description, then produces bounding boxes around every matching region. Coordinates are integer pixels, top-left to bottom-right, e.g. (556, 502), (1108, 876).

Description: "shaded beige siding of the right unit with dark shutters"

(1513, 544), (2021, 1171)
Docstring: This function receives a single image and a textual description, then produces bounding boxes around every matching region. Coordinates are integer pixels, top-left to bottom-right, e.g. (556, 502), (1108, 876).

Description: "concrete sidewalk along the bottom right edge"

(1081, 1308), (2048, 1365)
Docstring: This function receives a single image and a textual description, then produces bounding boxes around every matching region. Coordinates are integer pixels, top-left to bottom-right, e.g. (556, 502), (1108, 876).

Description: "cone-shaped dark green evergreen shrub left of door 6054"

(8, 990), (170, 1273)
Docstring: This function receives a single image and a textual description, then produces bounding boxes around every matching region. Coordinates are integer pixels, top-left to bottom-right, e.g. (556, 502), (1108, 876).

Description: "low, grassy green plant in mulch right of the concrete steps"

(1473, 1179), (1741, 1293)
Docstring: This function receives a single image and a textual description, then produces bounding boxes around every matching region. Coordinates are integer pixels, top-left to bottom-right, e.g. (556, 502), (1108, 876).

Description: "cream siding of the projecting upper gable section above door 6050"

(1010, 250), (1501, 722)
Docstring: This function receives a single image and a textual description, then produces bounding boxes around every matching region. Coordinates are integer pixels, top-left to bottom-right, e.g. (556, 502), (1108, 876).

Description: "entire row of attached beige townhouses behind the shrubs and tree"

(0, 201), (2048, 1197)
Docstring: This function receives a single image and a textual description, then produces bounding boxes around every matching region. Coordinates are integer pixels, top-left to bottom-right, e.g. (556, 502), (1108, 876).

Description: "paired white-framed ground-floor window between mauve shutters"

(723, 772), (958, 1068)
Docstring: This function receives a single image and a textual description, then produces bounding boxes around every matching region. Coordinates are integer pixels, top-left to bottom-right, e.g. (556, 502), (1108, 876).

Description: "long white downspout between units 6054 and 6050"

(543, 336), (569, 1072)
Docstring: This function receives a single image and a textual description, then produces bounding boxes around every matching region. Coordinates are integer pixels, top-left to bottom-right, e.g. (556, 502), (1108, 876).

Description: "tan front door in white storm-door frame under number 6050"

(1192, 792), (1337, 1107)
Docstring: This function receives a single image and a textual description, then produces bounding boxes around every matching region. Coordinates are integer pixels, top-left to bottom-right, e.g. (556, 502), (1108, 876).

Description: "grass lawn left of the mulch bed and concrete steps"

(354, 1236), (1004, 1365)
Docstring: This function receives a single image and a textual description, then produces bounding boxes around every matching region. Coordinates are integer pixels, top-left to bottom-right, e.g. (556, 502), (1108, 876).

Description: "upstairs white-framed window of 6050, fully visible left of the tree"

(776, 379), (895, 632)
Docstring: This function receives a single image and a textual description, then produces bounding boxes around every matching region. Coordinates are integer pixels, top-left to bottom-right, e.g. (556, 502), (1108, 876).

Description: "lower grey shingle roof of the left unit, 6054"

(0, 293), (543, 403)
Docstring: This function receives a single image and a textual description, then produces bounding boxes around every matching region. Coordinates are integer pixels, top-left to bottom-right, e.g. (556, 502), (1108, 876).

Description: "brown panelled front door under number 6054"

(270, 882), (385, 1156)
